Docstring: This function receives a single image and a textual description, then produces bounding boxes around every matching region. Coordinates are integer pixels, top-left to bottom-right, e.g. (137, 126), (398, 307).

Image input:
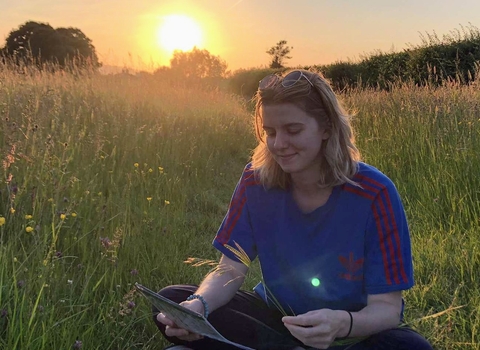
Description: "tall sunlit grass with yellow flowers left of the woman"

(0, 66), (251, 349)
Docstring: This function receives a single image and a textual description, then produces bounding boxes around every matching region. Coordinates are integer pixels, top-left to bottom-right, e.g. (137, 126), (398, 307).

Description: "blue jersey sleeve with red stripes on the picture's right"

(364, 181), (414, 294)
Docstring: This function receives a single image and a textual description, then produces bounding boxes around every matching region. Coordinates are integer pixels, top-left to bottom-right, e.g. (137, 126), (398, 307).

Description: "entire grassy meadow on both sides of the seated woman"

(0, 70), (480, 349)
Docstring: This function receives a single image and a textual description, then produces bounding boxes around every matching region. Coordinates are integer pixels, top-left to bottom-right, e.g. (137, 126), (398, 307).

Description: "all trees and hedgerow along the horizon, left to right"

(0, 21), (480, 97)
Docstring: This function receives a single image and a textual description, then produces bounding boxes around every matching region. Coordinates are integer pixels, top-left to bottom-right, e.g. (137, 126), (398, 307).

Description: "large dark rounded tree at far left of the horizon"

(3, 21), (100, 67)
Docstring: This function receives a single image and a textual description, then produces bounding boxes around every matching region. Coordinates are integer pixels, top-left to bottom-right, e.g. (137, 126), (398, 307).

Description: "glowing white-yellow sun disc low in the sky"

(158, 15), (202, 52)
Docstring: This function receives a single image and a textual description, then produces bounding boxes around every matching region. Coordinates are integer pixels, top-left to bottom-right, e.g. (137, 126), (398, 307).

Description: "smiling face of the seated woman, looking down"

(261, 103), (330, 177)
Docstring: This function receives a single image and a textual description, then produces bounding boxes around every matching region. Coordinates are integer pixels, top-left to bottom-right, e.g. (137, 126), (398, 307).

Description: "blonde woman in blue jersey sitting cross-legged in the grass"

(154, 70), (432, 350)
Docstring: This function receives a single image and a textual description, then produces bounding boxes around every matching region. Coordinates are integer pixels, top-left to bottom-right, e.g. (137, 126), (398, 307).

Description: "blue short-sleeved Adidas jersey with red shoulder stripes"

(213, 163), (413, 315)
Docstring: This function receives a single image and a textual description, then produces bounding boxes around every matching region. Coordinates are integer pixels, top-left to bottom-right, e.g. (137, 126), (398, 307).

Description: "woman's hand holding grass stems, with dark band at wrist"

(282, 309), (350, 349)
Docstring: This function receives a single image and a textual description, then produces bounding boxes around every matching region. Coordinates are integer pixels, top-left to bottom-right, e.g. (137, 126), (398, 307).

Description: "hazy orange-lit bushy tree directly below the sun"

(170, 47), (227, 78)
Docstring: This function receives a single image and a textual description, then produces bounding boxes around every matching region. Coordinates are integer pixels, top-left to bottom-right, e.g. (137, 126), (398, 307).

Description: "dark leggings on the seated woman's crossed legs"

(153, 285), (432, 350)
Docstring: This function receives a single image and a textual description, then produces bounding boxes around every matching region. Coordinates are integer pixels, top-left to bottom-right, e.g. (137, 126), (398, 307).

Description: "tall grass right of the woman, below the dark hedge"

(346, 81), (480, 349)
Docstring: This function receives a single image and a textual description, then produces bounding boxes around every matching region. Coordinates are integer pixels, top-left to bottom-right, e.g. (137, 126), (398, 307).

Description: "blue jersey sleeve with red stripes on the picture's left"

(212, 166), (257, 261)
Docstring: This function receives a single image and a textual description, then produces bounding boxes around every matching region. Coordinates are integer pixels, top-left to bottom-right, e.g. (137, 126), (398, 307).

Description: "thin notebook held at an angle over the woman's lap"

(135, 283), (254, 350)
